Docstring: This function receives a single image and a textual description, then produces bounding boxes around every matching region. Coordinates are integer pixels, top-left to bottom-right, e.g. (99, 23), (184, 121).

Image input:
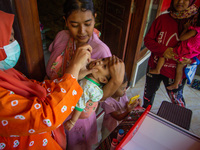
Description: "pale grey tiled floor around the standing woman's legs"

(127, 76), (200, 136)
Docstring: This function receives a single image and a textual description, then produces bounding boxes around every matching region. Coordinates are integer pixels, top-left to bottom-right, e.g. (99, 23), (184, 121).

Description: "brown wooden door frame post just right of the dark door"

(124, 0), (163, 81)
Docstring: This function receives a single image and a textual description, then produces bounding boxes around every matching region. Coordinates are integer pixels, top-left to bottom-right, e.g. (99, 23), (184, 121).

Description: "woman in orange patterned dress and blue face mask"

(0, 11), (92, 150)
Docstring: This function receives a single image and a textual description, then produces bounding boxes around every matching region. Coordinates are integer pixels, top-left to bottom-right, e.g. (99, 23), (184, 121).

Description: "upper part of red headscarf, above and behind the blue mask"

(0, 11), (14, 61)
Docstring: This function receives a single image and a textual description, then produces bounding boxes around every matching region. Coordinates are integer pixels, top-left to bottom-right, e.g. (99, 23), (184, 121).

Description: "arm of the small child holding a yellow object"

(110, 99), (142, 121)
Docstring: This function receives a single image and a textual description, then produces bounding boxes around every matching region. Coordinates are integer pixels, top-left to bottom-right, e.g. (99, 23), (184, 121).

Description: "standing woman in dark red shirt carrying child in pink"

(143, 0), (200, 108)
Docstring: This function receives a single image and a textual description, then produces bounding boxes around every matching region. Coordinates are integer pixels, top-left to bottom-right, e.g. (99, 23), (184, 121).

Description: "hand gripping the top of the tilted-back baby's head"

(109, 55), (125, 85)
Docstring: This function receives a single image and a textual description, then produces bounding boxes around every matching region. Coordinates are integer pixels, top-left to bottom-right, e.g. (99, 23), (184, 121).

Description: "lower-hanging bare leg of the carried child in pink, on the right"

(167, 63), (185, 90)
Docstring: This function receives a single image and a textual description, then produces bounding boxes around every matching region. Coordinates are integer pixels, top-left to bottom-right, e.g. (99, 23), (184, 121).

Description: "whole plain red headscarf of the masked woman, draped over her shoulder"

(0, 11), (46, 100)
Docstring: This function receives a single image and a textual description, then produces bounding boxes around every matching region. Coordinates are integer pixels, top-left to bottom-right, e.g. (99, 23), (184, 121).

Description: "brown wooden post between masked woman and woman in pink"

(13, 0), (46, 81)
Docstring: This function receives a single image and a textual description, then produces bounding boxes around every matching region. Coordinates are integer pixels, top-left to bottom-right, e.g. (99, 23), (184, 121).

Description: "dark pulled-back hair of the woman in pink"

(63, 0), (95, 19)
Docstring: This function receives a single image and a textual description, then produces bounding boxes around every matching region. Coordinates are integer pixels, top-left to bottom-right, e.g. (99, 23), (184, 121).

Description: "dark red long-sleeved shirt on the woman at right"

(144, 13), (200, 79)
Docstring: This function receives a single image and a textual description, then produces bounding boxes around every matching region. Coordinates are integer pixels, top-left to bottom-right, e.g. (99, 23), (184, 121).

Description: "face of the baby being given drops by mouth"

(88, 57), (110, 83)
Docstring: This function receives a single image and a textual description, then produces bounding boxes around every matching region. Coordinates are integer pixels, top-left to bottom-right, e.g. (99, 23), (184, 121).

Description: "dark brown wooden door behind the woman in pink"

(101, 0), (134, 61)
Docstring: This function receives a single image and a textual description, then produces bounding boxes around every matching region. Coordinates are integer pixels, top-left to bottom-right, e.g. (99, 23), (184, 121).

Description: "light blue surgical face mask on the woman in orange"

(0, 40), (21, 70)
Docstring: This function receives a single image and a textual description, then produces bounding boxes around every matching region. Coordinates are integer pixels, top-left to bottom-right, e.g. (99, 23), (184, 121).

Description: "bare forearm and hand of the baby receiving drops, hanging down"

(64, 109), (81, 131)
